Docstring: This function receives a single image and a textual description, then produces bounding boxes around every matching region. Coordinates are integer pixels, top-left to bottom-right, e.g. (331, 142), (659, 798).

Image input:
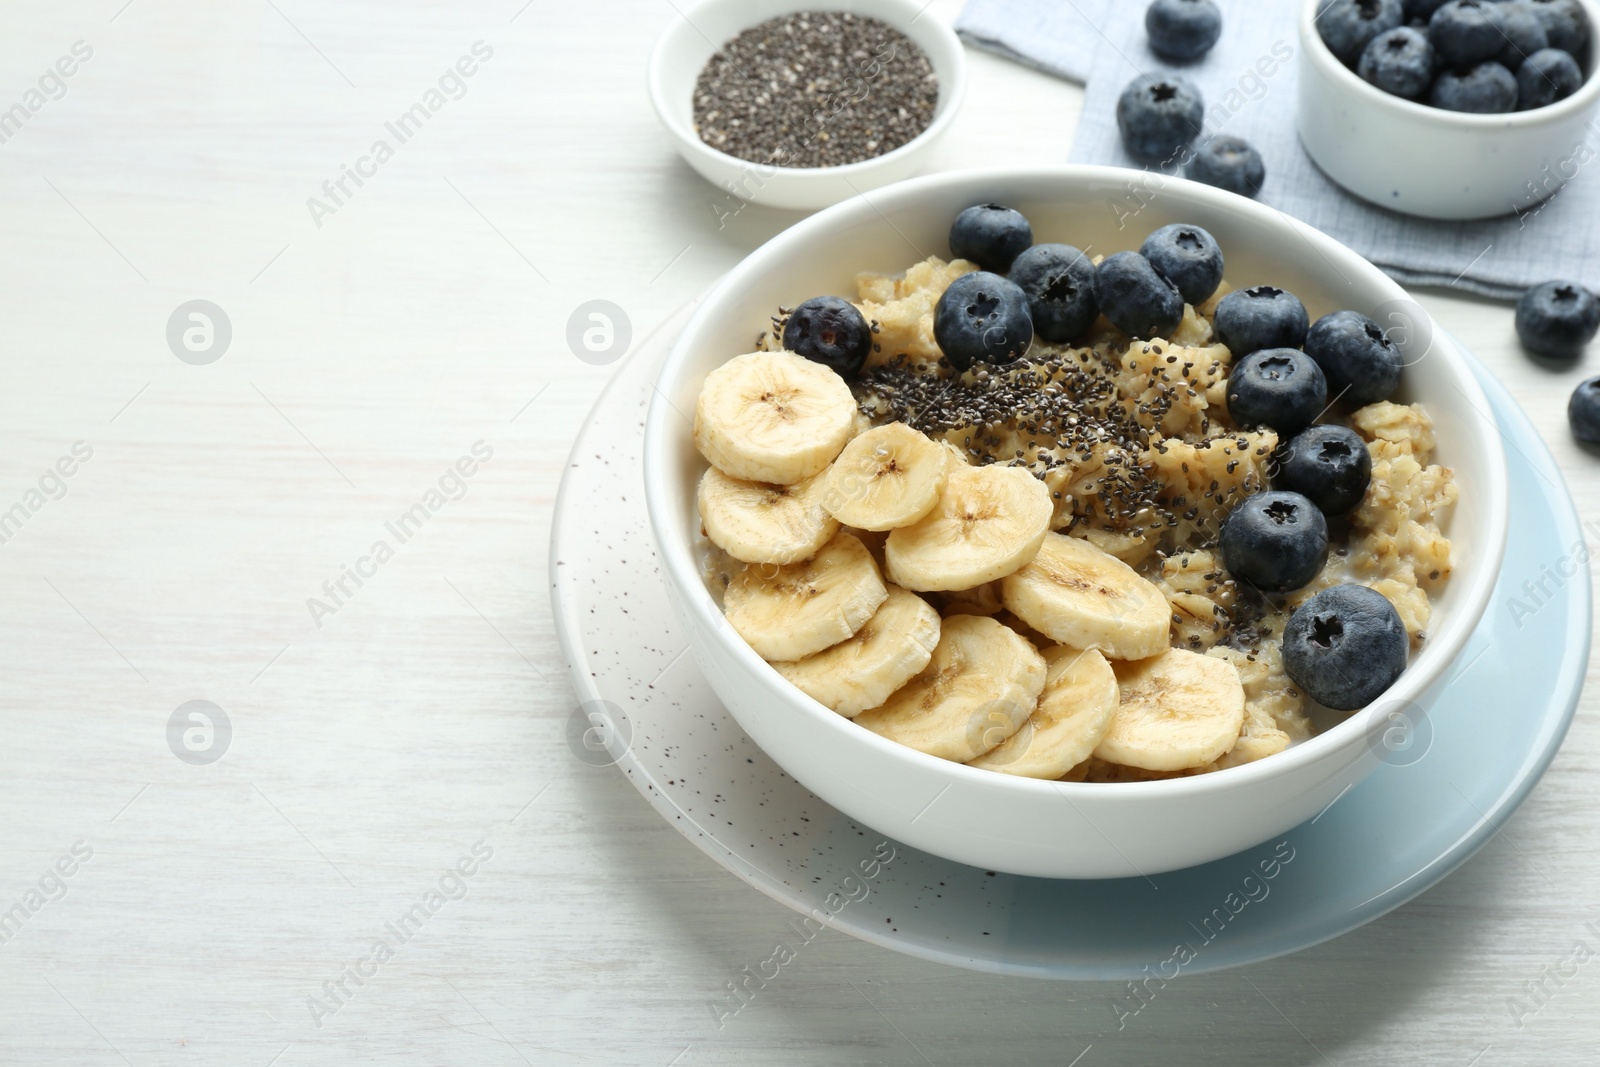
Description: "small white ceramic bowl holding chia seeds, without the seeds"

(650, 0), (966, 211)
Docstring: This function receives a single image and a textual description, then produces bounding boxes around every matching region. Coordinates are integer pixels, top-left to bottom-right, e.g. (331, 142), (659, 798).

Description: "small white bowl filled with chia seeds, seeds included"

(650, 0), (966, 213)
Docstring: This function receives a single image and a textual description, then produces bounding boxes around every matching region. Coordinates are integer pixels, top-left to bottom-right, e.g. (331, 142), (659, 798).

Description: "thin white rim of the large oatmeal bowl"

(643, 163), (1509, 800)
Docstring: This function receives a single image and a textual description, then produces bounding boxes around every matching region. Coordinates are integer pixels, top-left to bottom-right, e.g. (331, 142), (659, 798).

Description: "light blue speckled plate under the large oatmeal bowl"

(550, 317), (1590, 979)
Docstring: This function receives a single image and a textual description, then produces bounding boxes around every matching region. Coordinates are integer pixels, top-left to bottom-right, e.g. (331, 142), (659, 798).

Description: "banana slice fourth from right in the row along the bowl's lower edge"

(773, 585), (939, 718)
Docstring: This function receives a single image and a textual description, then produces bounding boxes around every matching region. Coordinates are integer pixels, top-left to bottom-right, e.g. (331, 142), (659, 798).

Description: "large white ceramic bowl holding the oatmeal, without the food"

(645, 166), (1507, 878)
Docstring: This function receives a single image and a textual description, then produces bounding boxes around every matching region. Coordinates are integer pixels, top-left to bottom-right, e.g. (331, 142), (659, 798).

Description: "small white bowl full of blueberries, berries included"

(1299, 0), (1600, 219)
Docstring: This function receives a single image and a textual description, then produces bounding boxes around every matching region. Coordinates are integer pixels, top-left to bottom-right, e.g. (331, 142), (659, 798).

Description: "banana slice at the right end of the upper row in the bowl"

(1004, 533), (1171, 659)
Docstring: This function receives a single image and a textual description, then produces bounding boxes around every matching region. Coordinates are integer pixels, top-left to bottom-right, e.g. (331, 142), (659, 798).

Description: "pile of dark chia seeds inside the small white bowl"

(694, 11), (939, 166)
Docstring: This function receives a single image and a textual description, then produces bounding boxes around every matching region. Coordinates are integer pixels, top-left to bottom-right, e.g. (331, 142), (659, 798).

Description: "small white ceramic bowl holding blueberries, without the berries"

(1298, 0), (1600, 219)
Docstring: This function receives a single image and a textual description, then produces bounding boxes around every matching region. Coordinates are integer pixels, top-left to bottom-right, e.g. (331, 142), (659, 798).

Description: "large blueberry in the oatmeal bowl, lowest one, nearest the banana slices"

(1283, 585), (1410, 712)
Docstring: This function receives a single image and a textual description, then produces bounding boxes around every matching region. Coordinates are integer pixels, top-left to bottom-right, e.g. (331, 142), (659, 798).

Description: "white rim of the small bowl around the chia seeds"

(645, 0), (966, 181)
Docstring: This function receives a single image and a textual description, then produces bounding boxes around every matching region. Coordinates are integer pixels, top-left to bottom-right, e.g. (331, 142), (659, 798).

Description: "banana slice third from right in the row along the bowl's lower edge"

(856, 614), (1046, 763)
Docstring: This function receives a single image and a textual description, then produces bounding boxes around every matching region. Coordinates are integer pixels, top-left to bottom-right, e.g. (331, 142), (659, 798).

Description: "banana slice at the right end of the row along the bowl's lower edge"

(1094, 648), (1245, 771)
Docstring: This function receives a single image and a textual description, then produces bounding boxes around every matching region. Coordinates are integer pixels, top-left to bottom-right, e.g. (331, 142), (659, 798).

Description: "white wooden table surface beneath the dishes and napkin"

(0, 0), (1600, 1067)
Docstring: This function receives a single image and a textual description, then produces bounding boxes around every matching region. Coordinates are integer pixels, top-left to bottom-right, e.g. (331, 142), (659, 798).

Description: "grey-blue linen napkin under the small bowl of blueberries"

(955, 0), (1600, 298)
